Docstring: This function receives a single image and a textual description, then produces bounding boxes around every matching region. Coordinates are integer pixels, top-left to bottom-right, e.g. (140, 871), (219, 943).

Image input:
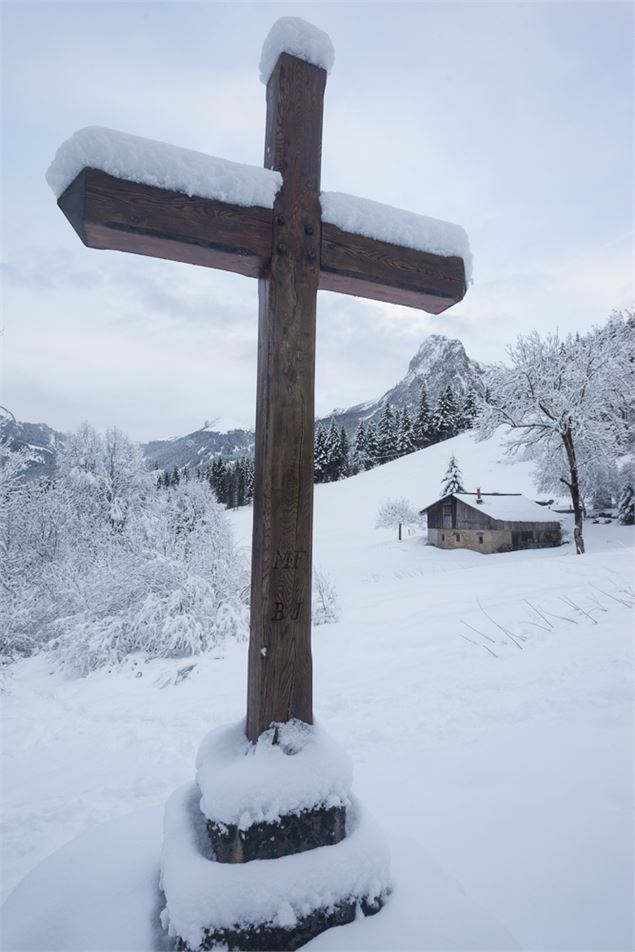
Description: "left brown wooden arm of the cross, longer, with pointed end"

(58, 168), (272, 278)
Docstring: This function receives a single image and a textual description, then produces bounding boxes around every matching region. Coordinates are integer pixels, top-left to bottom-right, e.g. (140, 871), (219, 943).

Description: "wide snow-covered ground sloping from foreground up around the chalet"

(2, 436), (633, 950)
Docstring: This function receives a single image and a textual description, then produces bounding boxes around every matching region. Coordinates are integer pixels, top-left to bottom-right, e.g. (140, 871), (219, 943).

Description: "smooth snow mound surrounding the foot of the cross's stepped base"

(1, 806), (518, 952)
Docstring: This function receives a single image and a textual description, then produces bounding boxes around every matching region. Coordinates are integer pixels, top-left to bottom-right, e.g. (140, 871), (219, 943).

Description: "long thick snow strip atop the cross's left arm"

(46, 126), (282, 208)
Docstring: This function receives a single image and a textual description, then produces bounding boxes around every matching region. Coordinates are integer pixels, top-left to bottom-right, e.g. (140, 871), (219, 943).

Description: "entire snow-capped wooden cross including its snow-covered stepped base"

(47, 18), (470, 950)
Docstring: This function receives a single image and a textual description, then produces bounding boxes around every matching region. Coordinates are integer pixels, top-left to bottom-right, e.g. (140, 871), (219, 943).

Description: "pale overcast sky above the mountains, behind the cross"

(0, 0), (633, 440)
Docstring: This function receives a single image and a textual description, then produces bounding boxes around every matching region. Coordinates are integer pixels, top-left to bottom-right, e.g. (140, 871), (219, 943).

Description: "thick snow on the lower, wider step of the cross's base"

(161, 784), (391, 949)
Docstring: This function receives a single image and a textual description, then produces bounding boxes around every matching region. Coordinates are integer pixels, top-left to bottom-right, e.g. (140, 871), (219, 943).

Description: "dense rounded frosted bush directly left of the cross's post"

(53, 482), (248, 673)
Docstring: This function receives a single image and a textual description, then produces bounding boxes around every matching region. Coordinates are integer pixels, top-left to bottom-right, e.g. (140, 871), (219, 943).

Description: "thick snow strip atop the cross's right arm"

(320, 192), (472, 284)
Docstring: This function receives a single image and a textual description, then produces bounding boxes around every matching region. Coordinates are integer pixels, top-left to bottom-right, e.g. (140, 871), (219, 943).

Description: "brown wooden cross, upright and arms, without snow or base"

(52, 37), (466, 741)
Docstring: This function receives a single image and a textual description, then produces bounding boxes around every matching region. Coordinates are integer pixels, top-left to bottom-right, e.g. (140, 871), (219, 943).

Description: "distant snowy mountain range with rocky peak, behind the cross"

(0, 334), (483, 476)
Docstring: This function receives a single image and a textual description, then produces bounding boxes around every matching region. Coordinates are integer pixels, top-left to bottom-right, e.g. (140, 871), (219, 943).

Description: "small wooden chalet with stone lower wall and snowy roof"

(421, 489), (562, 554)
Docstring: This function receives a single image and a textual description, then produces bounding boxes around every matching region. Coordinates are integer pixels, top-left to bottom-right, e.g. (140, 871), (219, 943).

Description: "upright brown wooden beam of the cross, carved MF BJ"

(247, 53), (326, 741)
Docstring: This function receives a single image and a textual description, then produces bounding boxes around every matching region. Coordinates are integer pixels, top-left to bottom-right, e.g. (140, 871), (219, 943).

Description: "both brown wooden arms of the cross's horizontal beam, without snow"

(58, 168), (466, 314)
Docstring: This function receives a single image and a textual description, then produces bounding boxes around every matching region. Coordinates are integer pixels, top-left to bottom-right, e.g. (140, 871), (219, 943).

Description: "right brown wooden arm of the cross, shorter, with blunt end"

(320, 222), (466, 314)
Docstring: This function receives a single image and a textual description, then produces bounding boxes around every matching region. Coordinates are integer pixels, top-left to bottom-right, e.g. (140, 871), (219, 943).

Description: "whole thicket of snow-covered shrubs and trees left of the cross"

(4, 424), (248, 674)
